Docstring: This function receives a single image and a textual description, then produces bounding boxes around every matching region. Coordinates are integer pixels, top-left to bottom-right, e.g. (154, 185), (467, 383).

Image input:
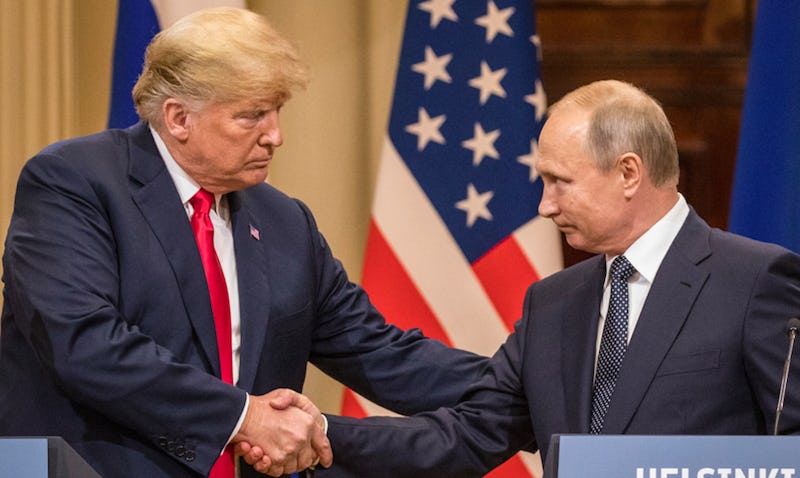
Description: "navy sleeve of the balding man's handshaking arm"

(320, 306), (536, 478)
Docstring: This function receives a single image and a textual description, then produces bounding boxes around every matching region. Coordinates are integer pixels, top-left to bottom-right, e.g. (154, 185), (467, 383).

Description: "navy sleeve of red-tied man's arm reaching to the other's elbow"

(301, 200), (487, 415)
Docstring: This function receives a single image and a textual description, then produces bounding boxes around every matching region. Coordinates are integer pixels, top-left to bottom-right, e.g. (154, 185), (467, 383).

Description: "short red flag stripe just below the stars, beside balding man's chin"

(472, 236), (539, 330)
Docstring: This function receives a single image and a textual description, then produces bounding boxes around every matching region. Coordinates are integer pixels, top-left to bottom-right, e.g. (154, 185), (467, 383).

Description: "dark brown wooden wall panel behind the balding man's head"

(536, 0), (755, 265)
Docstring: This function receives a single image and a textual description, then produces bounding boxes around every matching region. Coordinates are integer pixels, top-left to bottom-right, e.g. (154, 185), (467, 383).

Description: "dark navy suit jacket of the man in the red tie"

(0, 124), (485, 478)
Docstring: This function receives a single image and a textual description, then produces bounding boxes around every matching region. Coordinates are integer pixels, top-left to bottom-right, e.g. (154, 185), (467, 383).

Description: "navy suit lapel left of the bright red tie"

(129, 123), (220, 376)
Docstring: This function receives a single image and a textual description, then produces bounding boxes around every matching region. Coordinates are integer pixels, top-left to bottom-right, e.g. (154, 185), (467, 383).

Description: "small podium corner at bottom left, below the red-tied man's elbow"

(0, 437), (101, 478)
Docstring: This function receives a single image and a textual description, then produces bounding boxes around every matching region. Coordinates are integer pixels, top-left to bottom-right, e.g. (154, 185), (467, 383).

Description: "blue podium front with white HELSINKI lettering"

(544, 435), (800, 478)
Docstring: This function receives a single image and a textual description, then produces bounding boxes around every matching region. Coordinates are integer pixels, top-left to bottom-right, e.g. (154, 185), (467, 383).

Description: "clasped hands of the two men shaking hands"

(232, 389), (333, 476)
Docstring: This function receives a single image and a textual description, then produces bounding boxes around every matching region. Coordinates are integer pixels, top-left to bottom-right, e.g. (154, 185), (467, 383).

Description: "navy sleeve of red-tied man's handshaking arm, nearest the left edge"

(4, 155), (245, 473)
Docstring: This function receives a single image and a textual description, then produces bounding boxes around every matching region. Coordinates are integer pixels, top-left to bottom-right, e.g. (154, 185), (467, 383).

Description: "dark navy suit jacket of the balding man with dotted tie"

(320, 211), (800, 478)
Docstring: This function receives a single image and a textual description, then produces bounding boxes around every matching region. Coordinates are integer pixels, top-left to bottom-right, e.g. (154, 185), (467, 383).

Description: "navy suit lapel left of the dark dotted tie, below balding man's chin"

(561, 255), (605, 433)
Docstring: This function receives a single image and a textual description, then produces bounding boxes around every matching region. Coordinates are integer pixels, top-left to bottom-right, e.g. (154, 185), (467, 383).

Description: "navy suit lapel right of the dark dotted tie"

(603, 211), (711, 434)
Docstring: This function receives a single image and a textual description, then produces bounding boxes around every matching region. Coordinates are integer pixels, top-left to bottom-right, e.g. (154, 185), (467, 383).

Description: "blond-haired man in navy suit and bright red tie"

(0, 8), (486, 478)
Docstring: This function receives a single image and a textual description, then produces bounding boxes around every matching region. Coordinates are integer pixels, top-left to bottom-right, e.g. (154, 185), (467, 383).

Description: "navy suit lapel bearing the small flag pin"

(228, 192), (270, 390)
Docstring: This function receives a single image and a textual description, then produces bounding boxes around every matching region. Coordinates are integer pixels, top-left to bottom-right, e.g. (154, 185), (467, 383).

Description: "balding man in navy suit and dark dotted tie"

(314, 80), (800, 478)
